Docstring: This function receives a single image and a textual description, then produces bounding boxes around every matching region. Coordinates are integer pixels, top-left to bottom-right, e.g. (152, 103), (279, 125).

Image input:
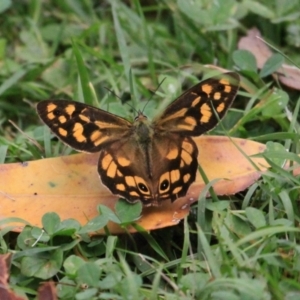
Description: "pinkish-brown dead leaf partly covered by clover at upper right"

(238, 28), (300, 90)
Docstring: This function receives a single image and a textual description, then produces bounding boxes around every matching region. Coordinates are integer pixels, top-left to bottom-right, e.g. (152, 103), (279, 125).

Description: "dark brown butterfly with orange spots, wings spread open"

(37, 72), (240, 206)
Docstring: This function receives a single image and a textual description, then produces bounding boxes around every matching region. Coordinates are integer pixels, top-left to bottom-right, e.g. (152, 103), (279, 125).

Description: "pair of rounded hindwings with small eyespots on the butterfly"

(98, 133), (198, 206)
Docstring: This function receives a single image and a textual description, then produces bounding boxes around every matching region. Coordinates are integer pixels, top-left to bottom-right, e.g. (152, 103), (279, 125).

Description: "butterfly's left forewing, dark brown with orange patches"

(37, 100), (132, 153)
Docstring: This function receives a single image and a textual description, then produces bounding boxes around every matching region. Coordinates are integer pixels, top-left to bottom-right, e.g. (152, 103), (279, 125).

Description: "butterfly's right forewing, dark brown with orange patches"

(154, 72), (240, 136)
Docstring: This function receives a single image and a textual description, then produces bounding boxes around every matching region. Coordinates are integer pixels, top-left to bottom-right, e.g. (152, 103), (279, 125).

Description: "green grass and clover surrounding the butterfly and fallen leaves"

(0, 0), (300, 300)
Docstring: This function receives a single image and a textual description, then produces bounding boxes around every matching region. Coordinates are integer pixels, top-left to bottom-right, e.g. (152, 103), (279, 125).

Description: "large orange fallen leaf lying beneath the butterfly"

(0, 136), (268, 233)
